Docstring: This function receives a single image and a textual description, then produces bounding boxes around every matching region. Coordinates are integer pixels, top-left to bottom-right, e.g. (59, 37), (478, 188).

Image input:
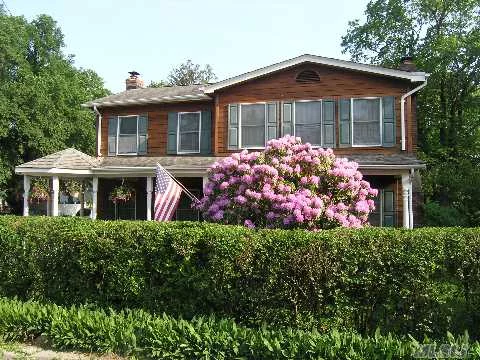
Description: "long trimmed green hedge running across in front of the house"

(0, 217), (480, 338)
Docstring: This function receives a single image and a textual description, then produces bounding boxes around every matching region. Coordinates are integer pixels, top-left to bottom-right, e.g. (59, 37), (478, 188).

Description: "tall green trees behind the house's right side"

(342, 0), (480, 225)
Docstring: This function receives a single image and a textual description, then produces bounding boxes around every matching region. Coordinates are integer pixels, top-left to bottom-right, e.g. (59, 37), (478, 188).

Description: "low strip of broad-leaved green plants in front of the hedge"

(0, 298), (480, 360)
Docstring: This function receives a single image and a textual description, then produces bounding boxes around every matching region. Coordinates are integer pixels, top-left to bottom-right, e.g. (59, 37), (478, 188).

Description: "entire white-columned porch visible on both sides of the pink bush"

(15, 149), (425, 228)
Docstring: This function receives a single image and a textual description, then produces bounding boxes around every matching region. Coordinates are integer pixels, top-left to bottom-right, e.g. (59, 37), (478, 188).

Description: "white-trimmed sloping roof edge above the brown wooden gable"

(204, 54), (428, 94)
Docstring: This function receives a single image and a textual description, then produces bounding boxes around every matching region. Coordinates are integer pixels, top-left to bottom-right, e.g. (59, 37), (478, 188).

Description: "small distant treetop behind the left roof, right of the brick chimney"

(149, 60), (216, 87)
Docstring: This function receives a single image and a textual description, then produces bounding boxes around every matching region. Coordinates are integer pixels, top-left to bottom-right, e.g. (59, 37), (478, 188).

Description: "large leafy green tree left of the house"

(0, 9), (108, 211)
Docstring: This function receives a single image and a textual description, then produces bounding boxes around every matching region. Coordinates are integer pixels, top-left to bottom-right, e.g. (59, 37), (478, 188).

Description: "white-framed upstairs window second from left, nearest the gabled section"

(177, 111), (201, 154)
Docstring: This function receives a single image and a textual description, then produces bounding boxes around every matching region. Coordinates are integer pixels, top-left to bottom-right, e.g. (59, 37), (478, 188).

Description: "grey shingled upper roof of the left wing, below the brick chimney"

(82, 85), (211, 107)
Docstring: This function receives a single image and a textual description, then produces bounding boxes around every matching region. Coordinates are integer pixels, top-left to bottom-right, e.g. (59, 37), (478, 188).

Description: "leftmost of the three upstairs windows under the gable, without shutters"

(240, 104), (267, 148)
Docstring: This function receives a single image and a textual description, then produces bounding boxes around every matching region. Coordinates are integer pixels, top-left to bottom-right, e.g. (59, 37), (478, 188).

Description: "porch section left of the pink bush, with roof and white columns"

(15, 149), (216, 220)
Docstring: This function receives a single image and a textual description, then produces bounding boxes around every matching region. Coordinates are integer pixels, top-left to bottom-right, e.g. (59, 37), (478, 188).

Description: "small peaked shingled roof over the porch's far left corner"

(15, 148), (98, 173)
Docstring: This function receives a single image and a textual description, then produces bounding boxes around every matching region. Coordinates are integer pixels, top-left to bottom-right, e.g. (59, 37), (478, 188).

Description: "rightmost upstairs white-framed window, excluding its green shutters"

(352, 98), (382, 146)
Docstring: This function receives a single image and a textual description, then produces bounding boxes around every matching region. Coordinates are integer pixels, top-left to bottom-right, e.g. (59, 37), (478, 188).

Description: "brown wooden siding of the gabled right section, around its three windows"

(214, 65), (416, 155)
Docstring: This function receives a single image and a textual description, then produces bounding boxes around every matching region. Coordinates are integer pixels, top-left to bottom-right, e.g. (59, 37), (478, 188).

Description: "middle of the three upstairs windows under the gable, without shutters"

(294, 101), (322, 146)
